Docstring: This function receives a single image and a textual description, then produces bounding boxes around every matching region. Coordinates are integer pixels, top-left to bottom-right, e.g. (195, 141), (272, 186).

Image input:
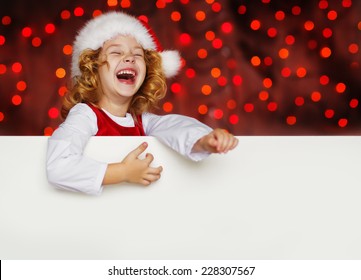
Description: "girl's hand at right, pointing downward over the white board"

(192, 128), (238, 153)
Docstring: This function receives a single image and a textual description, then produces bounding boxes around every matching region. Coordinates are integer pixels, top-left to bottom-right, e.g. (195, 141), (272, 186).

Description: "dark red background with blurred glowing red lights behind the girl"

(0, 0), (361, 135)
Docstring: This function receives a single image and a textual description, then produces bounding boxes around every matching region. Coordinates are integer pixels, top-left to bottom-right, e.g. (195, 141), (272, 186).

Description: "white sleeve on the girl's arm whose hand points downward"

(142, 113), (212, 161)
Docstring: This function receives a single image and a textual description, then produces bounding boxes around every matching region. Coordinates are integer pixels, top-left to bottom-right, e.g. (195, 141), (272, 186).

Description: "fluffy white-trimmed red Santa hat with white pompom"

(71, 12), (181, 78)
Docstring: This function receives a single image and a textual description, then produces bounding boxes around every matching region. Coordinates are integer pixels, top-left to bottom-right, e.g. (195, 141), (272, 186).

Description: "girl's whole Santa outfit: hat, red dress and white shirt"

(47, 12), (212, 194)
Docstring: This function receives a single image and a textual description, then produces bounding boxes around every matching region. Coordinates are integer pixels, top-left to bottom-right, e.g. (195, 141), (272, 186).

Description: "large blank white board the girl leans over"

(0, 136), (361, 259)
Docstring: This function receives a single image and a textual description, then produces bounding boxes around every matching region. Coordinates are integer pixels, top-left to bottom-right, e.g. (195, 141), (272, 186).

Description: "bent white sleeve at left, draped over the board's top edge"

(46, 104), (107, 195)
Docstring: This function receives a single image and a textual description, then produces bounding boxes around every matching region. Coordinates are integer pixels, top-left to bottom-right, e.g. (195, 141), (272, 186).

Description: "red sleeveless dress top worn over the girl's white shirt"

(88, 104), (146, 136)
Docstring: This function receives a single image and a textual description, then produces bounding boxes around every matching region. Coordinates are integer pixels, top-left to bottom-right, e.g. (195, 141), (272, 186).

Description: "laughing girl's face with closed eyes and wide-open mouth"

(99, 36), (146, 105)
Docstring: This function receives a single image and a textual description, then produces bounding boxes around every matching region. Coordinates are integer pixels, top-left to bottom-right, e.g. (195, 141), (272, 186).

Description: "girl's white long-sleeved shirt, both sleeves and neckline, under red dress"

(46, 103), (212, 195)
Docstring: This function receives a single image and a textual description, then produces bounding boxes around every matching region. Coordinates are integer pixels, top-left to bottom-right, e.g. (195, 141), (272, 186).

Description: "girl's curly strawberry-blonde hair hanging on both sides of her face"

(61, 48), (167, 119)
